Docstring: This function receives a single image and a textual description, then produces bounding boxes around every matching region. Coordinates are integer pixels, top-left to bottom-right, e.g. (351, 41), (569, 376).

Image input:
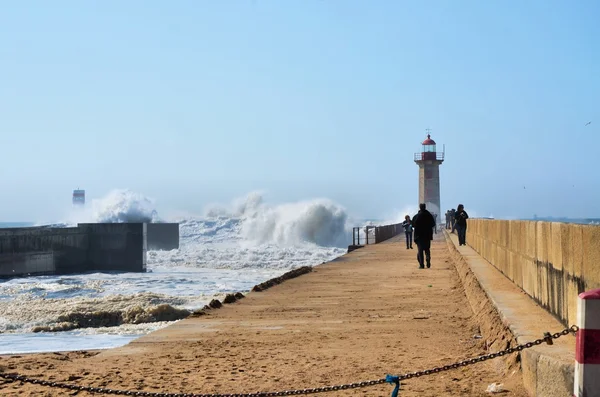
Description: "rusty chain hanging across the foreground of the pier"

(0, 325), (579, 397)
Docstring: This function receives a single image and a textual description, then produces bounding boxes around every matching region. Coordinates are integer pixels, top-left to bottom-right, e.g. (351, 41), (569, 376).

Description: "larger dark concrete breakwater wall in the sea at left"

(0, 223), (146, 277)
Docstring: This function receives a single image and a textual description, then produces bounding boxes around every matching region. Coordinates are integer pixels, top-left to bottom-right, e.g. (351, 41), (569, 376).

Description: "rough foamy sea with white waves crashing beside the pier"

(0, 190), (386, 354)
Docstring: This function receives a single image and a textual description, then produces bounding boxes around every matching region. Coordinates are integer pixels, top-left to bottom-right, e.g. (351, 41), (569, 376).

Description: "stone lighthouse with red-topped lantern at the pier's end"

(415, 128), (445, 217)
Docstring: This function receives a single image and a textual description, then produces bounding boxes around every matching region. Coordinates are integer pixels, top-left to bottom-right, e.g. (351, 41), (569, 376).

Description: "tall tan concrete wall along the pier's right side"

(467, 219), (600, 325)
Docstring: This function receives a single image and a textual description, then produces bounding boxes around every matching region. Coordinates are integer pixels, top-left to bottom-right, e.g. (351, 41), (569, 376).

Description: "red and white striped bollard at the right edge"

(574, 289), (600, 397)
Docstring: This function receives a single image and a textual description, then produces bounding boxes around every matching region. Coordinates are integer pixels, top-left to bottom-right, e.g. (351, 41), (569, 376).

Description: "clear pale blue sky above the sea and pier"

(0, 0), (600, 221)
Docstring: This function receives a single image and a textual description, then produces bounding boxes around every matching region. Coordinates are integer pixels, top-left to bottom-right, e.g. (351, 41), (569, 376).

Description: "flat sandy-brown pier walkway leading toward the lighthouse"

(0, 234), (526, 397)
